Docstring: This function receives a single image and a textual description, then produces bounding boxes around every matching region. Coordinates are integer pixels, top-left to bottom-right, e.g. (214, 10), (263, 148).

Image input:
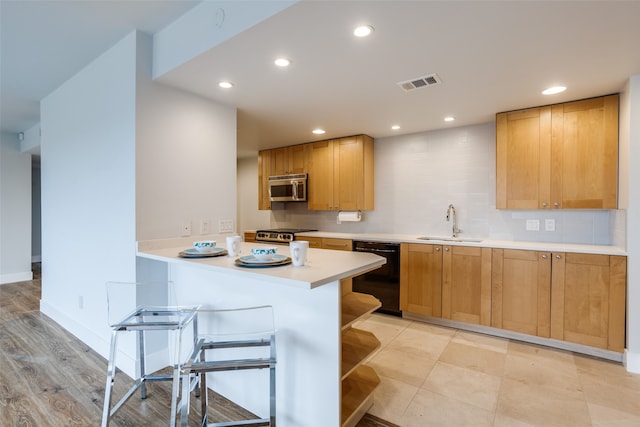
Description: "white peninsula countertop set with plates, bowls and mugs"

(137, 238), (386, 289)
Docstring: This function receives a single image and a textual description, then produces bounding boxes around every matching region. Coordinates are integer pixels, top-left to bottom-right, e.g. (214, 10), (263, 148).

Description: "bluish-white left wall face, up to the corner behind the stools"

(40, 33), (136, 354)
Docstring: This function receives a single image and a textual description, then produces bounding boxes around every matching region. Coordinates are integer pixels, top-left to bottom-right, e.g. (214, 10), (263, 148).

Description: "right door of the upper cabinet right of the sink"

(551, 95), (618, 209)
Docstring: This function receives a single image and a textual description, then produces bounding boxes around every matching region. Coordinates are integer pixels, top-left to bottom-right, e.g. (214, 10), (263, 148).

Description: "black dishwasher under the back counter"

(353, 241), (402, 316)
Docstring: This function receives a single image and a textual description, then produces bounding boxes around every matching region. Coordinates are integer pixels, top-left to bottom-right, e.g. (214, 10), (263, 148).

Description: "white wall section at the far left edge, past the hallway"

(0, 132), (33, 284)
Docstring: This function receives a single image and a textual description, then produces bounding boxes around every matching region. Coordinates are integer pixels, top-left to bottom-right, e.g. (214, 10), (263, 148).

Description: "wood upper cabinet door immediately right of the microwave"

(308, 141), (335, 211)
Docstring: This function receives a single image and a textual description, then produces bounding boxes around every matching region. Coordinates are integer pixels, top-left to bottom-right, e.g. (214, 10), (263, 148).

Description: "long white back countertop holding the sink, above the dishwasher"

(296, 231), (626, 255)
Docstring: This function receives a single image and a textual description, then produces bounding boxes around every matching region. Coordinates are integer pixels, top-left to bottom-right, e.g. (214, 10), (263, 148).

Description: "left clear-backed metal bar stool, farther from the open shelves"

(102, 282), (199, 427)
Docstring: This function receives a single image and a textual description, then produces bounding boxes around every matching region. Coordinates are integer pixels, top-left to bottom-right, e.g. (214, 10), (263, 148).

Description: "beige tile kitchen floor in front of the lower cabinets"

(356, 314), (640, 427)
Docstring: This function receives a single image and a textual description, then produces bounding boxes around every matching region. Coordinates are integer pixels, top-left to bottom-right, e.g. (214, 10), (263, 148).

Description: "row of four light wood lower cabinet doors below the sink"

(400, 243), (627, 352)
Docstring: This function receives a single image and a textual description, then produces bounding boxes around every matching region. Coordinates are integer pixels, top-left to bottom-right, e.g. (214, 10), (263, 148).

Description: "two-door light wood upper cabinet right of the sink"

(496, 95), (618, 209)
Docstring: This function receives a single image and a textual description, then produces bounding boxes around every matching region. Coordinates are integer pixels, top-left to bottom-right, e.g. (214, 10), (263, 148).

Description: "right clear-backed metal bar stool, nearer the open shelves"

(181, 306), (276, 427)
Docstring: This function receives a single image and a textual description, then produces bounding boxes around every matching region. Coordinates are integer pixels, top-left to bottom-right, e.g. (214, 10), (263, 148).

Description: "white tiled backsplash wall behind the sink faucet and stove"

(264, 122), (624, 244)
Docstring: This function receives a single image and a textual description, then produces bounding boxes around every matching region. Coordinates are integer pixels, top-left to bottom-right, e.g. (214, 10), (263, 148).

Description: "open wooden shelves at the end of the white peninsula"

(340, 290), (382, 427)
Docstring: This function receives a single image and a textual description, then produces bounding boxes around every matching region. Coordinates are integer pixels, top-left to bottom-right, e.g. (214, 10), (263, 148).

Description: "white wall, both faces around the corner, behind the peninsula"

(41, 32), (236, 364)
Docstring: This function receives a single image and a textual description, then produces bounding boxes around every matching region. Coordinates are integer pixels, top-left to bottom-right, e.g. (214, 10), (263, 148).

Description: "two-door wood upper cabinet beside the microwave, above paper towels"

(308, 135), (374, 210)
